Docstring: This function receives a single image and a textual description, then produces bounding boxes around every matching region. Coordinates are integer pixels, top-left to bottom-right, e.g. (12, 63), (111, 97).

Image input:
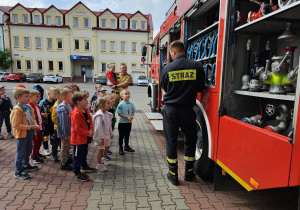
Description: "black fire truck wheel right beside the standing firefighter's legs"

(194, 105), (214, 178)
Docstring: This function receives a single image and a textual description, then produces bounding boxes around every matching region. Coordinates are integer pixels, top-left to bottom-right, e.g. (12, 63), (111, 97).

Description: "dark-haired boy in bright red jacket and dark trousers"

(69, 92), (96, 181)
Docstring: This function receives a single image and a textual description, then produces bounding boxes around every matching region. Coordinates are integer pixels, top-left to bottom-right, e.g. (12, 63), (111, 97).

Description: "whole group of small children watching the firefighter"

(0, 84), (135, 181)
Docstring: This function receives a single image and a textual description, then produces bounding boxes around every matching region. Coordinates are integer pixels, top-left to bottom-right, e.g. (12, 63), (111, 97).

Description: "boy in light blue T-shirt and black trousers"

(117, 89), (136, 155)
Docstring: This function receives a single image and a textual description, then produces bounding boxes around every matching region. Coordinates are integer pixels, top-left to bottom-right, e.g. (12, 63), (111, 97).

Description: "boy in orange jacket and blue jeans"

(10, 88), (40, 180)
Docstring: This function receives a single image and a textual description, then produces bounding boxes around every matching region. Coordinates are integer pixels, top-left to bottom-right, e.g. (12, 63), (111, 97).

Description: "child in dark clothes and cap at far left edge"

(0, 85), (14, 140)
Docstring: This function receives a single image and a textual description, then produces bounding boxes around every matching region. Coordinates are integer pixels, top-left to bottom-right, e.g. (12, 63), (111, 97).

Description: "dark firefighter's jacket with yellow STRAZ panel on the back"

(160, 55), (205, 107)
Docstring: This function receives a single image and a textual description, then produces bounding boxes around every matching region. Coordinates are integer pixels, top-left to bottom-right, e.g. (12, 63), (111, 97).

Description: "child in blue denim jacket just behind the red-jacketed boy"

(55, 88), (73, 171)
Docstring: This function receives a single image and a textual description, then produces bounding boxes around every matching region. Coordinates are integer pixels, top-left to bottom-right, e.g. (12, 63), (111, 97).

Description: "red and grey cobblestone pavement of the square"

(0, 85), (298, 210)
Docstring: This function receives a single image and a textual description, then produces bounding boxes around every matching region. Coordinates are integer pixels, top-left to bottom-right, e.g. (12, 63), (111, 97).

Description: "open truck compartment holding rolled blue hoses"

(184, 0), (220, 87)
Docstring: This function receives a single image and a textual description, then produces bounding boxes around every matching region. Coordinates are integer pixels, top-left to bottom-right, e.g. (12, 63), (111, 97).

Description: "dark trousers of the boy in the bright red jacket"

(73, 144), (88, 176)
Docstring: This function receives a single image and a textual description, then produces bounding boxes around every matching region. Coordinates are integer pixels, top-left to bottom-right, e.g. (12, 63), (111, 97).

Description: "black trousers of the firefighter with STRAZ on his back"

(163, 104), (197, 163)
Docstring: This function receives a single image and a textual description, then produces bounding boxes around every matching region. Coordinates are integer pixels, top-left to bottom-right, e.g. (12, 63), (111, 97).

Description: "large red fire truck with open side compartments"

(143, 0), (300, 191)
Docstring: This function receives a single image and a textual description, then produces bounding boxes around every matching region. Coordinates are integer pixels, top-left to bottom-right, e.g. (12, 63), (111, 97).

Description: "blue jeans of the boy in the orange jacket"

(15, 133), (33, 171)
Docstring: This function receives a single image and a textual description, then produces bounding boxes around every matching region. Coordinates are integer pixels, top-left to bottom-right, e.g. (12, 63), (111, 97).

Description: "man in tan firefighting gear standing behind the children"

(111, 64), (132, 108)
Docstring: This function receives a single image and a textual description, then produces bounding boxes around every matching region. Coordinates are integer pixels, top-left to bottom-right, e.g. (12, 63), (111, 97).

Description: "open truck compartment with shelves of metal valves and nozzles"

(222, 1), (300, 138)
